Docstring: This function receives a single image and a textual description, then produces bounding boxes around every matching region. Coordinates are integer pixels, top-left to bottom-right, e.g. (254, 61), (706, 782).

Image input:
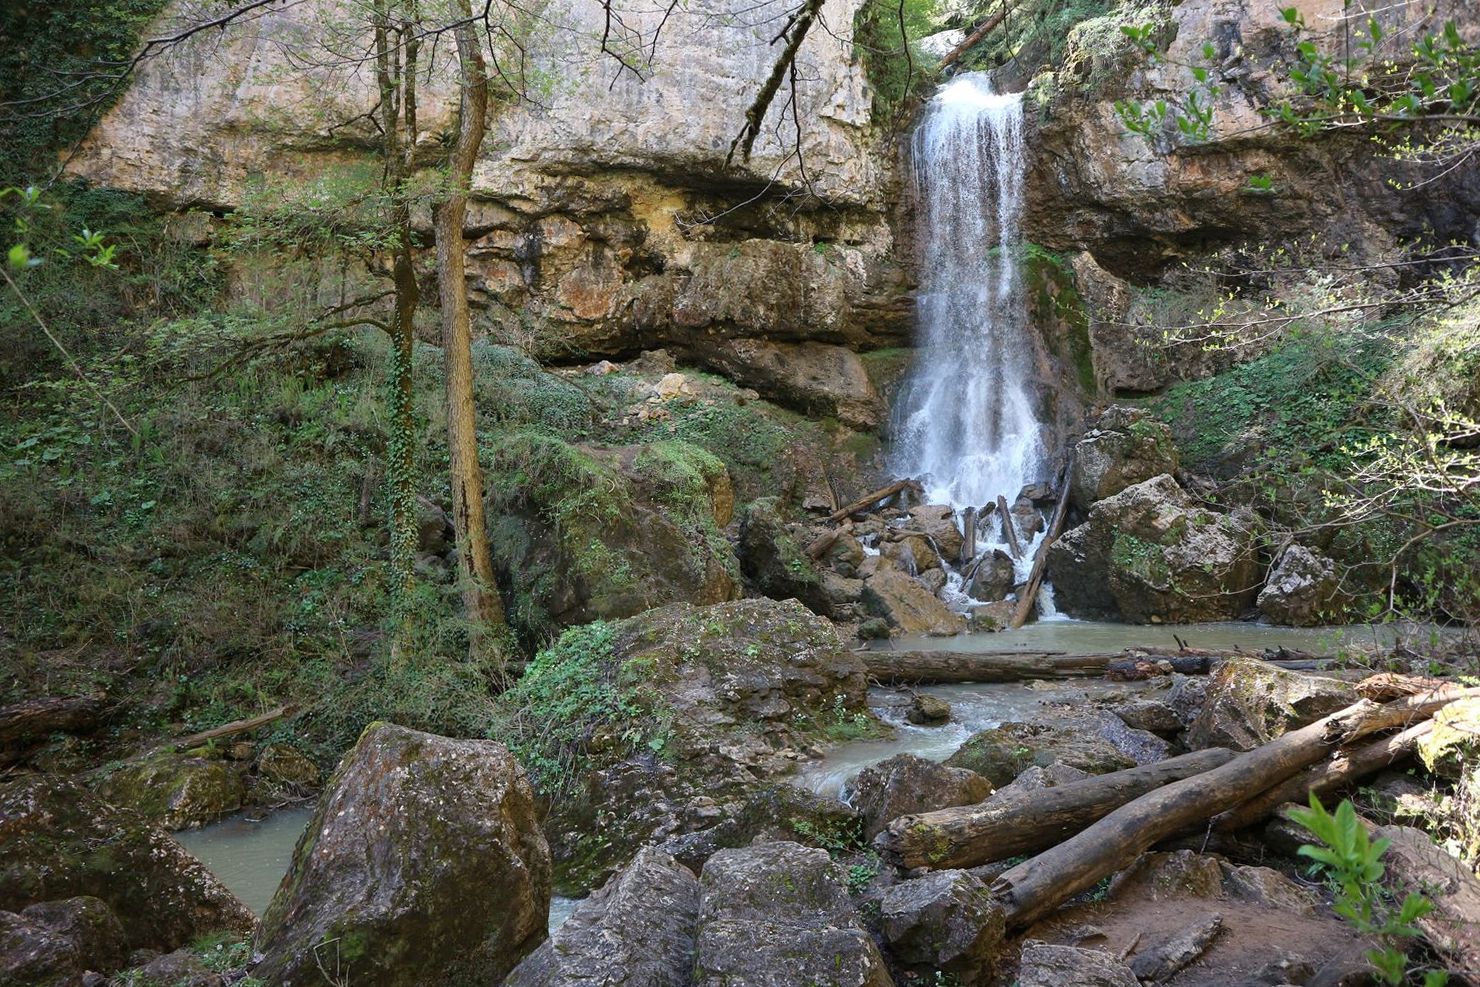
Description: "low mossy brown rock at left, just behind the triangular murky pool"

(98, 755), (247, 830)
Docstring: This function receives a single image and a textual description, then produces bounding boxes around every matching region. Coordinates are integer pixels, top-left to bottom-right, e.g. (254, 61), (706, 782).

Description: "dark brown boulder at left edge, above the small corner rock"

(0, 775), (253, 950)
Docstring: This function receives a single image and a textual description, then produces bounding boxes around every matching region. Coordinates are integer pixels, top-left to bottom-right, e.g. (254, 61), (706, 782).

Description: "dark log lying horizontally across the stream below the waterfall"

(858, 650), (1311, 685)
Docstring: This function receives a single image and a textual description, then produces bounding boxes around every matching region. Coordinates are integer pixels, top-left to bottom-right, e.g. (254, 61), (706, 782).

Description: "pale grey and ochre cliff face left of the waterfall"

(71, 0), (909, 410)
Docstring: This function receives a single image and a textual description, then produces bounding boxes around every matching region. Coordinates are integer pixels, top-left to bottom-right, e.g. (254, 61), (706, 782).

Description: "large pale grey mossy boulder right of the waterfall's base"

(1048, 474), (1259, 623)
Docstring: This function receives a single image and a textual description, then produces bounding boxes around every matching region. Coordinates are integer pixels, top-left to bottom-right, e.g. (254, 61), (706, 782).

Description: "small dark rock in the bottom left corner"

(0, 895), (129, 987)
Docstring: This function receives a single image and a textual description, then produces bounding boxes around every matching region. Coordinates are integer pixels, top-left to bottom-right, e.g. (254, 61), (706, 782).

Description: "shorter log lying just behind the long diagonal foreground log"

(875, 747), (1234, 869)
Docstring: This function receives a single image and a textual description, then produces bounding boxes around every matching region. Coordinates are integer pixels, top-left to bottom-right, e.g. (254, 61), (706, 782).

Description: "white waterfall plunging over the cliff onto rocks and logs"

(891, 73), (1045, 508)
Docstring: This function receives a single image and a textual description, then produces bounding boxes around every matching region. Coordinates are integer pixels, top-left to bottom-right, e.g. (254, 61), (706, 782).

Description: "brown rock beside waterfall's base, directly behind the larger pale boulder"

(1069, 405), (1178, 511)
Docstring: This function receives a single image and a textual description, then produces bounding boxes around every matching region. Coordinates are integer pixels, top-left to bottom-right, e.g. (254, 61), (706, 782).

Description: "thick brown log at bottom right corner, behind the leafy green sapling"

(1277, 805), (1480, 983)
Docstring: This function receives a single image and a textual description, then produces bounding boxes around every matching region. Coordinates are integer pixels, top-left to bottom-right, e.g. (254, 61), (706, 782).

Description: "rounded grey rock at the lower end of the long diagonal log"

(879, 870), (1006, 983)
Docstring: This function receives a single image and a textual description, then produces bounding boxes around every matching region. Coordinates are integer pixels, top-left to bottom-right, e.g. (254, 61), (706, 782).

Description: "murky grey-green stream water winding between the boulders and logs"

(175, 620), (1432, 931)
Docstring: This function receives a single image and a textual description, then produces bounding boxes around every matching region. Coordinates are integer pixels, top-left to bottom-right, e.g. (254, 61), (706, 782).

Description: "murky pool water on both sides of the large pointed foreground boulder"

(175, 805), (577, 931)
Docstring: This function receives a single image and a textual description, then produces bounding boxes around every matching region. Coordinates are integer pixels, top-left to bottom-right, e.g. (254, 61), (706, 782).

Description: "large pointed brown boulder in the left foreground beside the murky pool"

(253, 724), (551, 987)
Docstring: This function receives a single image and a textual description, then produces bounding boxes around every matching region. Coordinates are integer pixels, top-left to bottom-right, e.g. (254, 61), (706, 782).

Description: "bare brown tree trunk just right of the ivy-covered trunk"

(435, 0), (505, 662)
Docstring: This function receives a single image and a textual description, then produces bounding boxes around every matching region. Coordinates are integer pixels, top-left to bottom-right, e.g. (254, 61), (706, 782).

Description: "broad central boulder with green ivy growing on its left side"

(499, 598), (887, 894)
